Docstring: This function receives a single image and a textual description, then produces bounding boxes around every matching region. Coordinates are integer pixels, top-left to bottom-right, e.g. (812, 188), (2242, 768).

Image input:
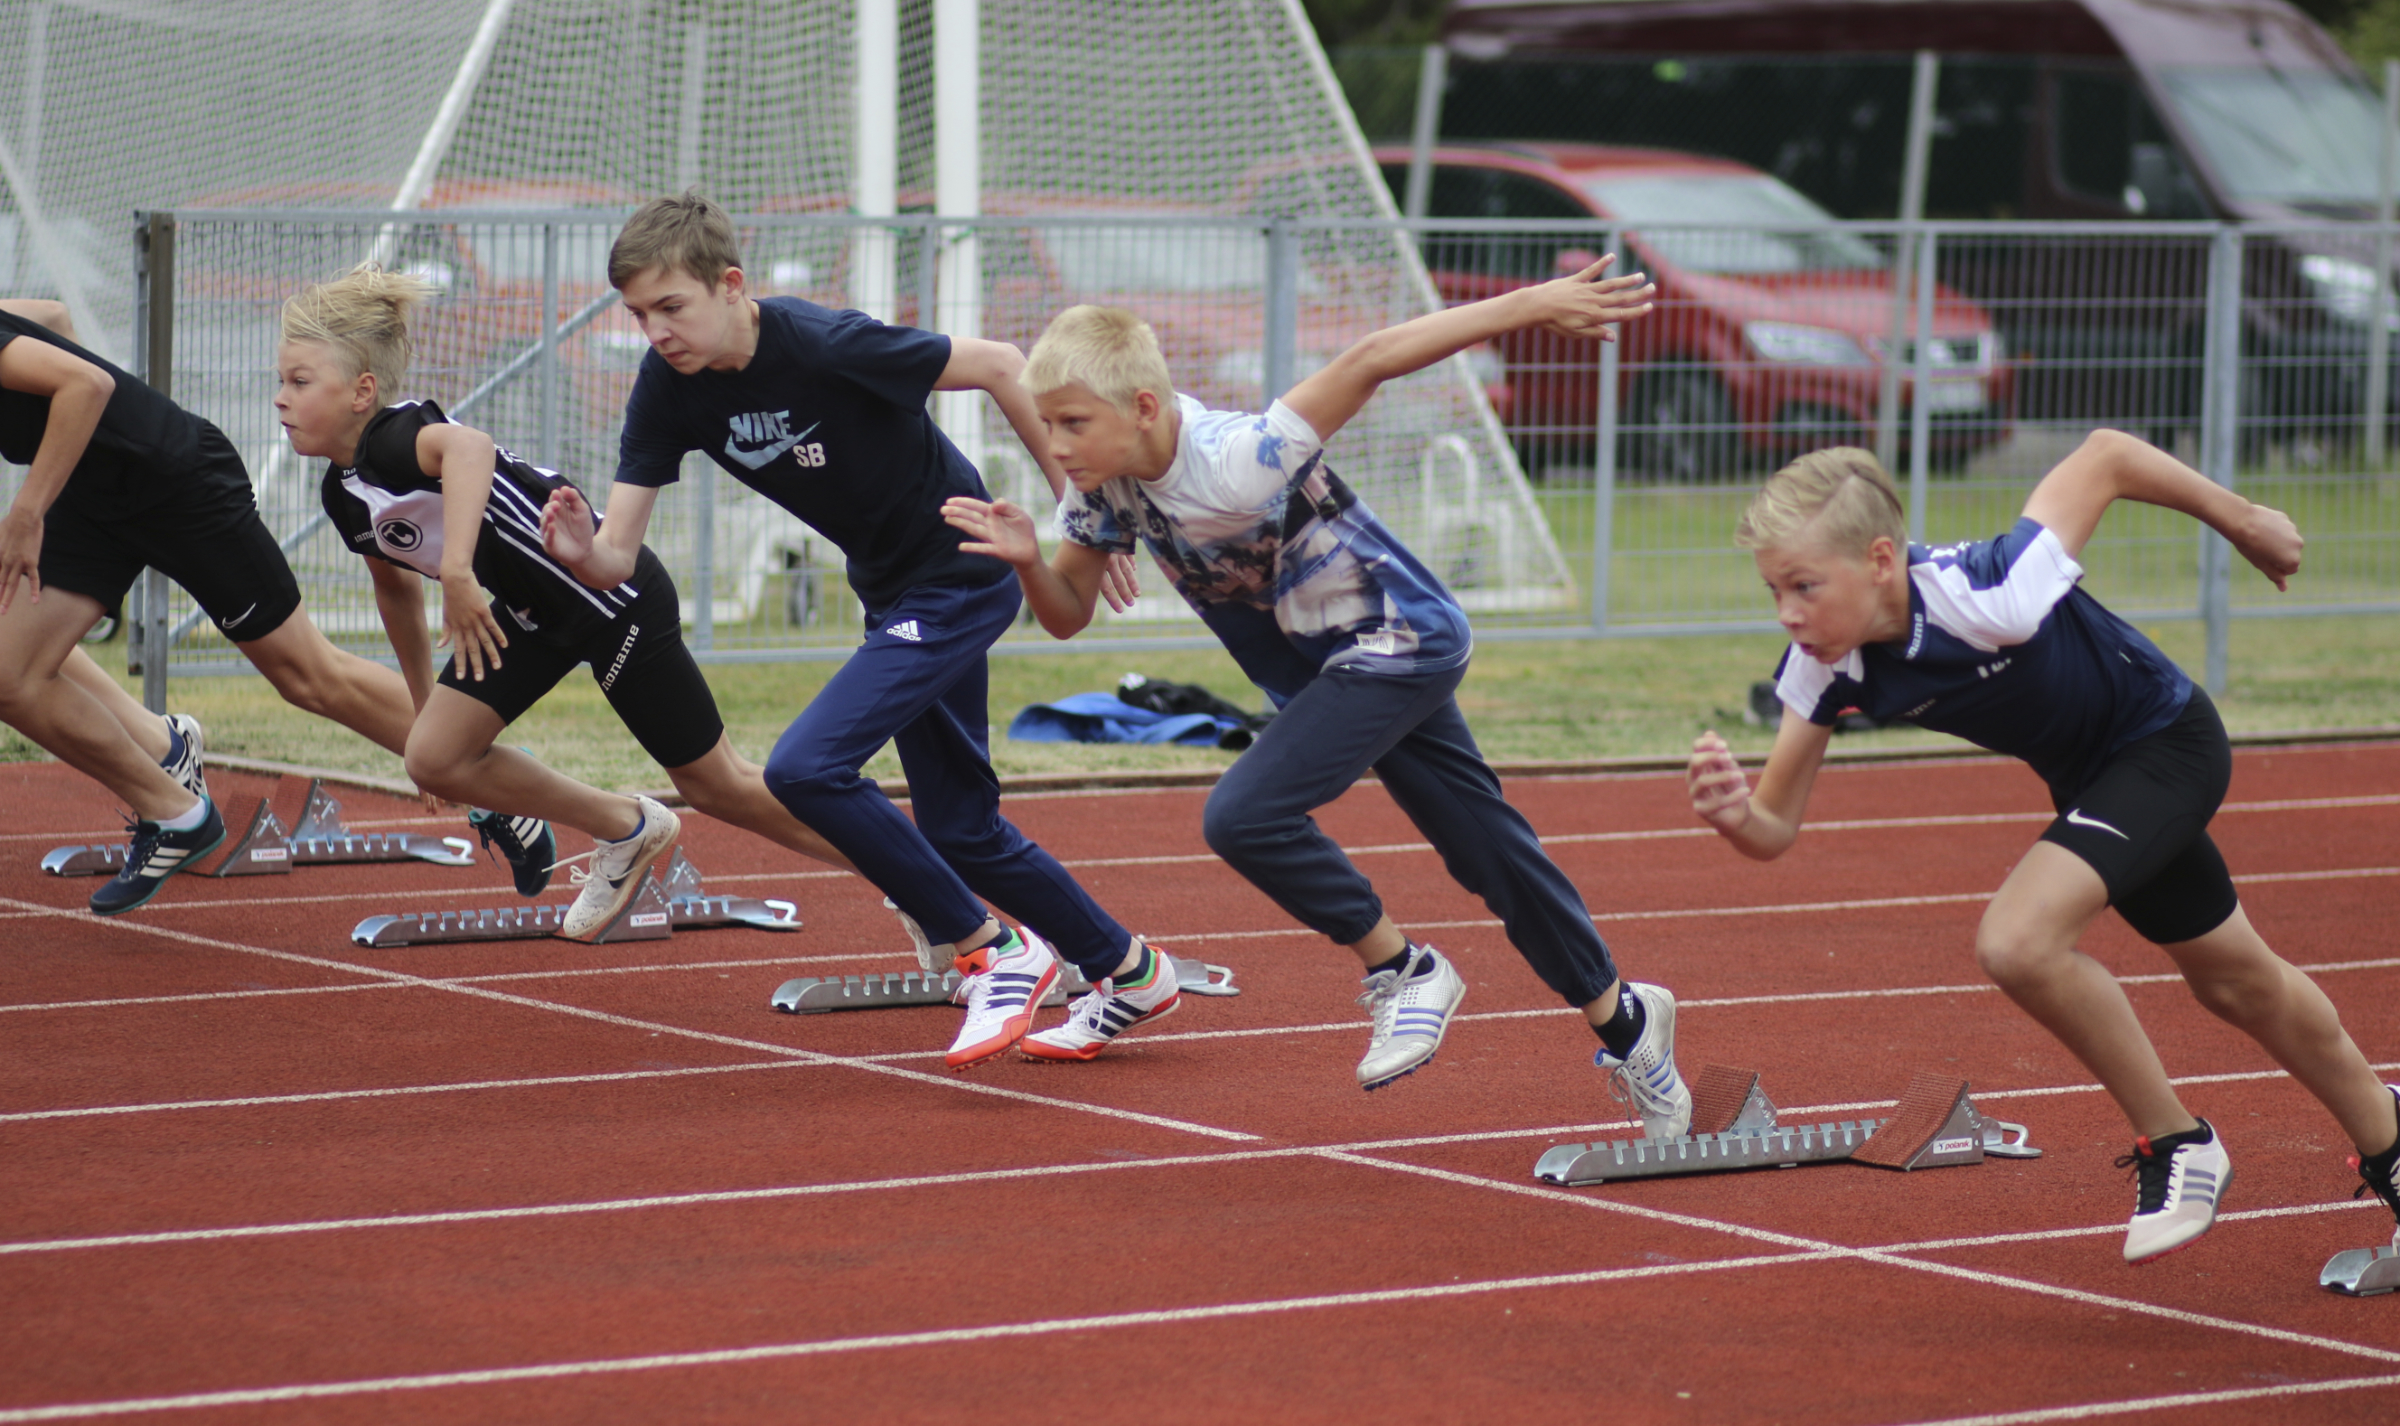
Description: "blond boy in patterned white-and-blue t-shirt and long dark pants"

(943, 259), (1692, 1136)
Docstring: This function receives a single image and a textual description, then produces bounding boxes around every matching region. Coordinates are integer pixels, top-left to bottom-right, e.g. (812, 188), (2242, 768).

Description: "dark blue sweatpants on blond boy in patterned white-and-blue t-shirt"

(1202, 665), (1618, 1006)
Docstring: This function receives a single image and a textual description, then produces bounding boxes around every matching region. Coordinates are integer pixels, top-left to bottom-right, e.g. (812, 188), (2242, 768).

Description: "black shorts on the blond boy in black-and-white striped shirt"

(442, 550), (725, 768)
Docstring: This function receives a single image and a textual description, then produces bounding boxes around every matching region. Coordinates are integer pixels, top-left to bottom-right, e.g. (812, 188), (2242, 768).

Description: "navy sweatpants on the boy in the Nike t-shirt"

(766, 579), (1133, 982)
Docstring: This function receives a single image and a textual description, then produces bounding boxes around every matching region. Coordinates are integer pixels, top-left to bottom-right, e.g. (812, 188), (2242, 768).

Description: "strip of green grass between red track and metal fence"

(42, 603), (2400, 787)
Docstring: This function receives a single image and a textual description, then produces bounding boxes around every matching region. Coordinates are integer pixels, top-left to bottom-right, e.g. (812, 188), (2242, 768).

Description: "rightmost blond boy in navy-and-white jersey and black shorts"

(1687, 430), (2400, 1263)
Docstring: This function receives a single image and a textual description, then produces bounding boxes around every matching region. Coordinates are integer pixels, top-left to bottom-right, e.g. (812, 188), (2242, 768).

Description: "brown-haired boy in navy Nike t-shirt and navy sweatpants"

(542, 192), (1178, 1068)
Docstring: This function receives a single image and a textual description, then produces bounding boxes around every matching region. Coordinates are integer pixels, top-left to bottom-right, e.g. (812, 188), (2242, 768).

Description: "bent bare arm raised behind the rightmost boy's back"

(2026, 430), (2306, 588)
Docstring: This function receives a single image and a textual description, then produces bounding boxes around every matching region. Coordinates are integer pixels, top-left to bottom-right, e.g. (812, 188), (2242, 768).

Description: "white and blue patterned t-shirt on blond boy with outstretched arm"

(1058, 396), (1474, 691)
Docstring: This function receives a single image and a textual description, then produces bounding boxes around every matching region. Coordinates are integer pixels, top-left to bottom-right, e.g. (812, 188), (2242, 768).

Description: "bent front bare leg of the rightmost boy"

(1975, 843), (2201, 1138)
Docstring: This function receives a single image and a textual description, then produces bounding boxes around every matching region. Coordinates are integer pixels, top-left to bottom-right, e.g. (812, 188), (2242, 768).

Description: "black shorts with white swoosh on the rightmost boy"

(2042, 687), (2239, 946)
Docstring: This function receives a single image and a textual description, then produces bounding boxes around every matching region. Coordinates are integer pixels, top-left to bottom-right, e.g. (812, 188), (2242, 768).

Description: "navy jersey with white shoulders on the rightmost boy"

(1776, 519), (2191, 797)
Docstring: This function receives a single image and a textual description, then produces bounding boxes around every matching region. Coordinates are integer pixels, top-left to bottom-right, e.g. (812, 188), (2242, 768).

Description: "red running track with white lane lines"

(0, 744), (2400, 1426)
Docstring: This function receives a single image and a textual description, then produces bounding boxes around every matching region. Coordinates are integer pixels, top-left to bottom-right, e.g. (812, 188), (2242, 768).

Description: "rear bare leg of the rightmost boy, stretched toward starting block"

(2162, 907), (2400, 1155)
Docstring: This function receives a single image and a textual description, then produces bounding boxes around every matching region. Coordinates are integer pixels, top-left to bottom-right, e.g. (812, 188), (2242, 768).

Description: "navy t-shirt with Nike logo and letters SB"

(617, 298), (1008, 612)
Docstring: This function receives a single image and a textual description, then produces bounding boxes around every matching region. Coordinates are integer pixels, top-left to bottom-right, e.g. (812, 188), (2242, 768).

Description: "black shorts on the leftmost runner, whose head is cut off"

(41, 423), (300, 643)
